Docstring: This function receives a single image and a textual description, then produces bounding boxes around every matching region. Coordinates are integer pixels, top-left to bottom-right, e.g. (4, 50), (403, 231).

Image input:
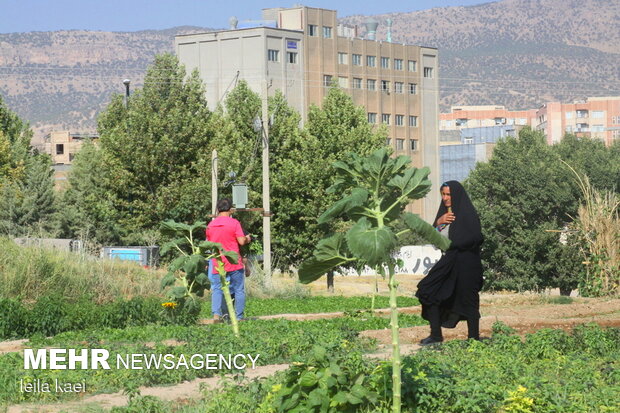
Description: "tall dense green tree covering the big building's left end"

(67, 54), (213, 243)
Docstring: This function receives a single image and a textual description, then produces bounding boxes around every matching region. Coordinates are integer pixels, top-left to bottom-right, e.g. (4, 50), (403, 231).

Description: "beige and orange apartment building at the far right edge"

(536, 96), (620, 145)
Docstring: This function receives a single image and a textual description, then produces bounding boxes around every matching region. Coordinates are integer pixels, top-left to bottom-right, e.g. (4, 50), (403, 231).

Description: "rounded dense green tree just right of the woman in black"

(466, 129), (578, 290)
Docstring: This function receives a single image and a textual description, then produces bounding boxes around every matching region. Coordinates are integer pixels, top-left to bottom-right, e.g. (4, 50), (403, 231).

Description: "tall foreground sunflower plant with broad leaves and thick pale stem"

(299, 148), (450, 412)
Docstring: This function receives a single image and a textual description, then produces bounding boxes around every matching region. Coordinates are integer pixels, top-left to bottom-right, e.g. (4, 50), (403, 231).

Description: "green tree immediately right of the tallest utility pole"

(271, 87), (387, 265)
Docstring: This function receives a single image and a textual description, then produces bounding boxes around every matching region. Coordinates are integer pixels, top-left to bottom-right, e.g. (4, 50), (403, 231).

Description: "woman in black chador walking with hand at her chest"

(416, 181), (483, 345)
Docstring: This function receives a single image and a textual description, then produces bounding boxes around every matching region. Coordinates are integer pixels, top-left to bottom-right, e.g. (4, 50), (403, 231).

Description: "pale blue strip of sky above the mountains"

(0, 0), (489, 33)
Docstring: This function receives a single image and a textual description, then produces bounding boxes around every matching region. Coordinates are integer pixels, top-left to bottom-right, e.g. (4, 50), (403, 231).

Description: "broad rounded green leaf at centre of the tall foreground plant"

(346, 218), (396, 267)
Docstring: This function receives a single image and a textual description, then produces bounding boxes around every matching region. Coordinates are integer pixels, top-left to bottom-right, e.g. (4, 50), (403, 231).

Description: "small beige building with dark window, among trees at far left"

(44, 131), (99, 188)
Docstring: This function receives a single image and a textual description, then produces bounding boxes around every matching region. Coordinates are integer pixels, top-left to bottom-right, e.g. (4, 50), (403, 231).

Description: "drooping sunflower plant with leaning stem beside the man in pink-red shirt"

(160, 220), (239, 336)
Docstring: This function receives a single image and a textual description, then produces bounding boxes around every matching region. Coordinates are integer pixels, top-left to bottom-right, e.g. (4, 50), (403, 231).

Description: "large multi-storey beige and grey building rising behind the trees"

(175, 6), (439, 218)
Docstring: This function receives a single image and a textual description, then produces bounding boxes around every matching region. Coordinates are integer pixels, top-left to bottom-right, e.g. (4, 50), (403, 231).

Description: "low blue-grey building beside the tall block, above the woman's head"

(439, 125), (523, 182)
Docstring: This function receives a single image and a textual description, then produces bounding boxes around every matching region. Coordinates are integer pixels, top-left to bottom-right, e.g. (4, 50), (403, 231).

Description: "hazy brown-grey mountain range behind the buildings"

(0, 0), (620, 140)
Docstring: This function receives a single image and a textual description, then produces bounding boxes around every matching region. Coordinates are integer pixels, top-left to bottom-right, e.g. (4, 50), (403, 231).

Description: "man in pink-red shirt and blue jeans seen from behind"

(206, 198), (250, 320)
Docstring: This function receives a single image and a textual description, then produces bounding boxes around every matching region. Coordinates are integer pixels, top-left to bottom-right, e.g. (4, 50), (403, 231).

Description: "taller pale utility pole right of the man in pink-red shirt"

(262, 79), (271, 277)
